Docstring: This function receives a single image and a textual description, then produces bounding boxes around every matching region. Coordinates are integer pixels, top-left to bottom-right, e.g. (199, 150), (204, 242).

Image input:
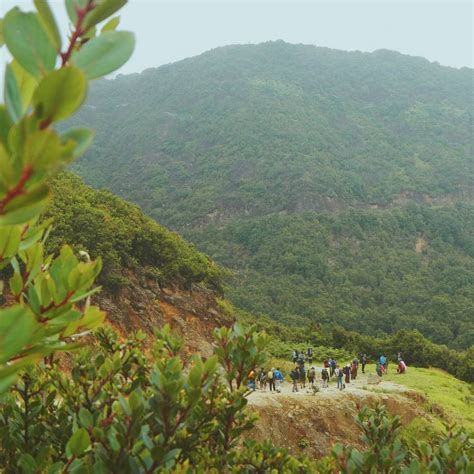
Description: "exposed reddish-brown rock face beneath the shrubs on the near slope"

(94, 272), (233, 357)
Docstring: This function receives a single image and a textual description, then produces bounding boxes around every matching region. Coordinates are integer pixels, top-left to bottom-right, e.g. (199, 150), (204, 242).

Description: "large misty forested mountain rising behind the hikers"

(70, 41), (474, 348)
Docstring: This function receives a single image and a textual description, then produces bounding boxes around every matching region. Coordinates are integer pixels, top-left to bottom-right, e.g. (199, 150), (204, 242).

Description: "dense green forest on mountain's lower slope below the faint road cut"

(195, 204), (474, 349)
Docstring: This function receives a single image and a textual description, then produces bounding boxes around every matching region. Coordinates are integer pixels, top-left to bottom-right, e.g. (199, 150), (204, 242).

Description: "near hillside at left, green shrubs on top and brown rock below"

(41, 174), (232, 354)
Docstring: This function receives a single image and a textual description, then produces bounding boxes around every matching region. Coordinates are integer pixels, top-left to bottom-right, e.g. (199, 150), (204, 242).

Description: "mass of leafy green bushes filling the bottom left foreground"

(0, 326), (309, 473)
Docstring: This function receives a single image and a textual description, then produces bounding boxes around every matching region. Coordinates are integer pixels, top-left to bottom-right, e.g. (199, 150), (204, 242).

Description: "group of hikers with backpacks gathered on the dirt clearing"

(248, 348), (407, 393)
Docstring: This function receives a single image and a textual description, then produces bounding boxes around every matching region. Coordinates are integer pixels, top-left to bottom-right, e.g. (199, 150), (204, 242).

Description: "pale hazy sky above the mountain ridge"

(0, 0), (473, 79)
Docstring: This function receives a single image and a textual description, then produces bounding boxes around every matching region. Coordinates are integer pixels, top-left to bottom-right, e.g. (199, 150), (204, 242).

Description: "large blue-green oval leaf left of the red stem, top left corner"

(3, 8), (56, 77)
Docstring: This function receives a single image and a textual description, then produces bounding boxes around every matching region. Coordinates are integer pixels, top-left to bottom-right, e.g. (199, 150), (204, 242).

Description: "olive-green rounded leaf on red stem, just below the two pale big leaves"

(33, 66), (87, 122)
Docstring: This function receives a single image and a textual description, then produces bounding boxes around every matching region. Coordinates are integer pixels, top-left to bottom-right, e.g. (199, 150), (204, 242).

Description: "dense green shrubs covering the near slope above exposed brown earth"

(45, 172), (222, 291)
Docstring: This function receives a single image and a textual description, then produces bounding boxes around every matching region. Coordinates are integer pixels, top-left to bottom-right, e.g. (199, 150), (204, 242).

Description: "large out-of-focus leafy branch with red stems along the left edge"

(0, 0), (134, 388)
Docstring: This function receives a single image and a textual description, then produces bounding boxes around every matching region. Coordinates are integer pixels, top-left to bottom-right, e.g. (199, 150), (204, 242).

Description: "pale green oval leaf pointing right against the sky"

(71, 31), (135, 79)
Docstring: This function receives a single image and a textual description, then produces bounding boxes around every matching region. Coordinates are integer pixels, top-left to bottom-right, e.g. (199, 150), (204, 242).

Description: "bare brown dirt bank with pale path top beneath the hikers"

(248, 375), (430, 457)
